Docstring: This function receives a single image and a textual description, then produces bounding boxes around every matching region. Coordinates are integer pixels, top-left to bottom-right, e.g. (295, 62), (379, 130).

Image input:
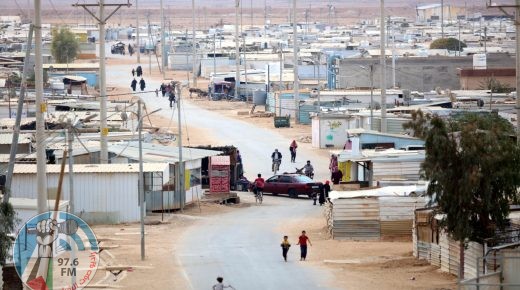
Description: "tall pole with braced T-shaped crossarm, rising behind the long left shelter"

(72, 0), (131, 164)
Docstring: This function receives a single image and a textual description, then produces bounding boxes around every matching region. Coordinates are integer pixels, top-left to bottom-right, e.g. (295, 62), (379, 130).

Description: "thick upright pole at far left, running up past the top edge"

(34, 0), (48, 213)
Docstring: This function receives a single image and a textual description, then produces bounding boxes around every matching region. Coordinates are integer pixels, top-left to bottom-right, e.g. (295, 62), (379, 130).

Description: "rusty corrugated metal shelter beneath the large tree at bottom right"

(413, 208), (520, 289)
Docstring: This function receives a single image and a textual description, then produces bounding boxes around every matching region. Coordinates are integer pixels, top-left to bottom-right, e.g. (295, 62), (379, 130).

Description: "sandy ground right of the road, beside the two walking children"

(279, 211), (456, 290)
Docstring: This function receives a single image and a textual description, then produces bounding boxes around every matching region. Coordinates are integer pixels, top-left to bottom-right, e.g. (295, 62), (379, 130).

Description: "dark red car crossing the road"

(264, 174), (323, 198)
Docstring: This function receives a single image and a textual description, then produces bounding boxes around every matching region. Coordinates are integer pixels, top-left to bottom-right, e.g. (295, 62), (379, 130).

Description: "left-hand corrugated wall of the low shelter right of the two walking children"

(332, 198), (380, 240)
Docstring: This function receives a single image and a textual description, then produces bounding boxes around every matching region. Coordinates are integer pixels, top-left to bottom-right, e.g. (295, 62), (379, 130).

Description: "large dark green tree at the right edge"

(405, 113), (520, 277)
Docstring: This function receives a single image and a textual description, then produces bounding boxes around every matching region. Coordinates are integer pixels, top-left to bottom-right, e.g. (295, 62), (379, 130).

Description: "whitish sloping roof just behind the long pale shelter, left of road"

(108, 141), (222, 163)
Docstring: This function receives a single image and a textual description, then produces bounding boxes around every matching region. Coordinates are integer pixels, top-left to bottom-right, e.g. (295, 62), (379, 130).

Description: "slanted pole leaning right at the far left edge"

(4, 24), (33, 203)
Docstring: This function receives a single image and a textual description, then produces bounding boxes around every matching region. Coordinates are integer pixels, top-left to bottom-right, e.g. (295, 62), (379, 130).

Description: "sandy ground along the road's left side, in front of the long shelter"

(91, 203), (246, 289)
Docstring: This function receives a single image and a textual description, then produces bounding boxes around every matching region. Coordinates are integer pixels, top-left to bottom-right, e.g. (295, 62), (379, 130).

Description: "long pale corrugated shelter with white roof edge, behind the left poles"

(11, 162), (169, 224)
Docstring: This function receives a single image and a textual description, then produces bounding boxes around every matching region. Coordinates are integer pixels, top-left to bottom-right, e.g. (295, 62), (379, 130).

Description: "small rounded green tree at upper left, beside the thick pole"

(51, 27), (79, 63)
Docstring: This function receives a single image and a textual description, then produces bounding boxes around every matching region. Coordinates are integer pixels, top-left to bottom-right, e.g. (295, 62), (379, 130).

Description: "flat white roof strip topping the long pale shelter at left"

(14, 163), (168, 174)
